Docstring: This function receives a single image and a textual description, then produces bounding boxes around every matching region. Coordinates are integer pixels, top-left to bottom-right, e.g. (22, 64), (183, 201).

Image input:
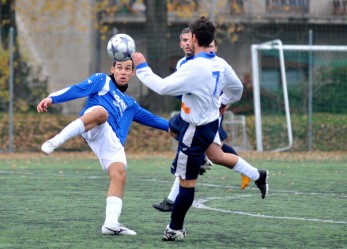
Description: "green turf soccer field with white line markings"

(0, 153), (347, 249)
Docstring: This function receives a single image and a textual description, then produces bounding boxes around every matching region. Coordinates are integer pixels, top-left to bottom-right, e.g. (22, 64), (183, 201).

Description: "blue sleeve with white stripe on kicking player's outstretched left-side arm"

(49, 73), (107, 103)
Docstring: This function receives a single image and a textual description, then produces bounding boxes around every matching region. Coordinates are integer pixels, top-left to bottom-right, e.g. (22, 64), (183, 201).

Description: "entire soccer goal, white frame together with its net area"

(251, 40), (347, 151)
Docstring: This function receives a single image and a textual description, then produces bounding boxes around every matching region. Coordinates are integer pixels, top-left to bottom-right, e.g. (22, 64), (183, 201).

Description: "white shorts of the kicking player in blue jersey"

(82, 106), (127, 172)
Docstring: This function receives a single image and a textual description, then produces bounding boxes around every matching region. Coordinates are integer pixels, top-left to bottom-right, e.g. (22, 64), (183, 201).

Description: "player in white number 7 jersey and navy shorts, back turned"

(132, 17), (268, 240)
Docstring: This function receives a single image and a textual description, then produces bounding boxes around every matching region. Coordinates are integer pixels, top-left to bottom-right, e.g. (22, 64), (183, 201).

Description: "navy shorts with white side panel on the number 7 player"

(171, 119), (219, 180)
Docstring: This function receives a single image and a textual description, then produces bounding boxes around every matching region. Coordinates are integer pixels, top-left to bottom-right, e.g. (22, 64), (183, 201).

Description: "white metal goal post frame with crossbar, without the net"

(251, 40), (347, 152)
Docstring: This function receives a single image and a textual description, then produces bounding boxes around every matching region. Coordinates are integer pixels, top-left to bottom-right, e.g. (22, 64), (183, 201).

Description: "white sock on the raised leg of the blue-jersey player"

(52, 118), (85, 147)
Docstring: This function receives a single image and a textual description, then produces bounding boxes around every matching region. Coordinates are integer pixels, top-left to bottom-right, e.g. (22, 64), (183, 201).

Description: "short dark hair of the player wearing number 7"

(189, 16), (216, 48)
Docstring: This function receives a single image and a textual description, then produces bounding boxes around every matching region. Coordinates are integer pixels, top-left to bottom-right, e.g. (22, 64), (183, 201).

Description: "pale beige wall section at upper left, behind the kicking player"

(16, 0), (94, 113)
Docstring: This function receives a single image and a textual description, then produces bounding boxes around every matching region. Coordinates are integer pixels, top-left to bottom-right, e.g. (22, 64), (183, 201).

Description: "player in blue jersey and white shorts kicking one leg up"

(37, 57), (169, 235)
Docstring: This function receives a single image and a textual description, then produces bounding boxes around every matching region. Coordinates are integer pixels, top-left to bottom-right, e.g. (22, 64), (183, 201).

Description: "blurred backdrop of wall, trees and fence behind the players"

(0, 0), (347, 152)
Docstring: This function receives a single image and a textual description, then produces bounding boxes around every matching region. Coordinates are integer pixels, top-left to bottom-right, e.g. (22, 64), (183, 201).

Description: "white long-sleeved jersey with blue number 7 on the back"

(136, 52), (243, 126)
